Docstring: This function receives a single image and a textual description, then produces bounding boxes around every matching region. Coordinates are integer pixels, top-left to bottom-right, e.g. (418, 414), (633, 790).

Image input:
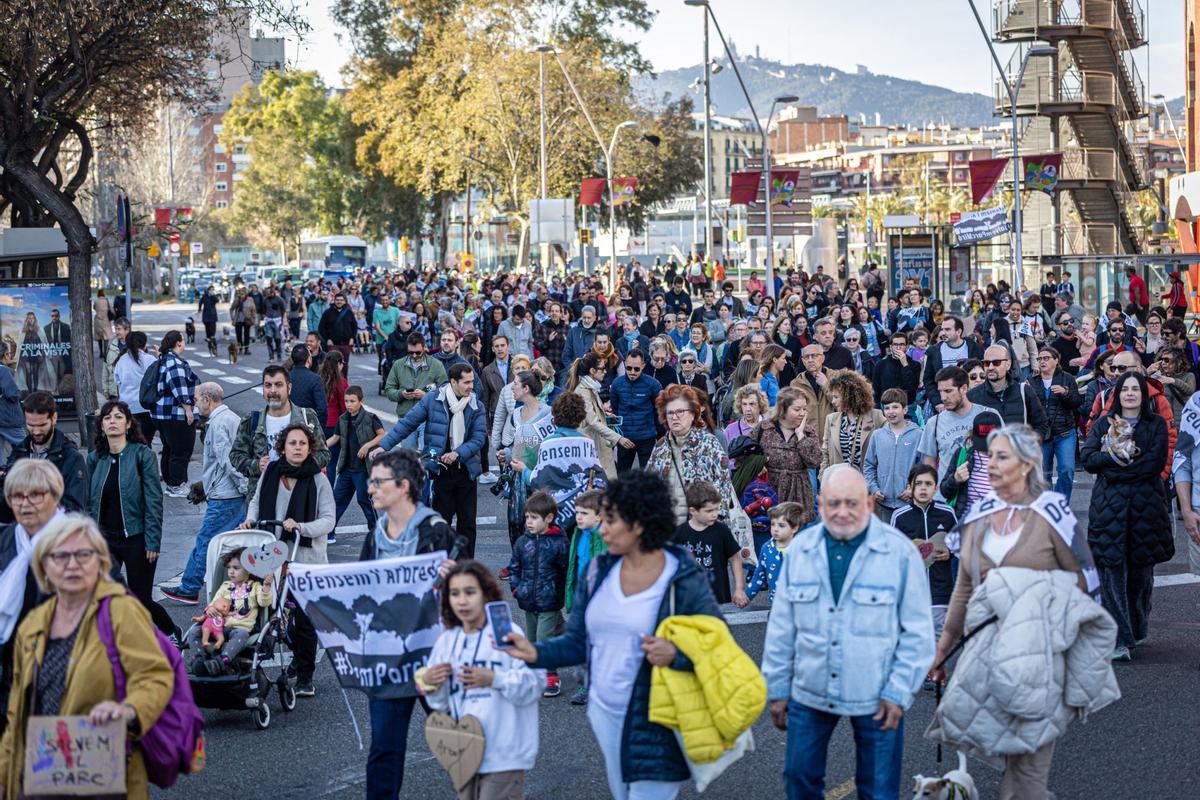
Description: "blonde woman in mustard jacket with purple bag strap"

(0, 515), (175, 799)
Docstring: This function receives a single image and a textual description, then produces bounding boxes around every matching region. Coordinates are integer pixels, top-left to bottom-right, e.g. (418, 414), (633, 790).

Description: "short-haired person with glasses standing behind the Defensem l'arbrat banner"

(359, 449), (455, 800)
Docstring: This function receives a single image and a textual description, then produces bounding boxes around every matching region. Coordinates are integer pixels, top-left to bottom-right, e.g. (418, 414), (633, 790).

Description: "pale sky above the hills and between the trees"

(288, 0), (1184, 99)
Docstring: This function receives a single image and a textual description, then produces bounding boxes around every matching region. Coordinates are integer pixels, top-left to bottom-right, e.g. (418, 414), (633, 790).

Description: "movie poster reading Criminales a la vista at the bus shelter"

(0, 278), (75, 414)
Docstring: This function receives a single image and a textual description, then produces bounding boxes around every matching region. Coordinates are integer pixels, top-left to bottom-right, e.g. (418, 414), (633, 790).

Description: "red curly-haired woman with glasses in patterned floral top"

(646, 384), (733, 524)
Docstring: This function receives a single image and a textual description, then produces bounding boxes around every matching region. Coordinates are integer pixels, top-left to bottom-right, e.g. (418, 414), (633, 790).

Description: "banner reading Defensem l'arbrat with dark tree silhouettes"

(288, 551), (446, 698)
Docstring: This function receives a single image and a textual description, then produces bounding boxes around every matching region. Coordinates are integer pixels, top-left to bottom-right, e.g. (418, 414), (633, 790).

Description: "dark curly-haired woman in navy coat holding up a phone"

(508, 472), (727, 800)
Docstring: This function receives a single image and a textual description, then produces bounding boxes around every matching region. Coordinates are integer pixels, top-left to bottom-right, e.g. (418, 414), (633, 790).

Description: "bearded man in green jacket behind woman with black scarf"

(229, 363), (329, 494)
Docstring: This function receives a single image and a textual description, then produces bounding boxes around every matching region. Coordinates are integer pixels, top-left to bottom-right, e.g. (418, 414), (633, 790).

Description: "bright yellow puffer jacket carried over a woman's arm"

(649, 614), (767, 764)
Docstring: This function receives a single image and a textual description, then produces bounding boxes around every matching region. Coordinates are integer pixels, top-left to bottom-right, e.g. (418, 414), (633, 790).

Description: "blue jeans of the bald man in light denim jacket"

(784, 700), (904, 800)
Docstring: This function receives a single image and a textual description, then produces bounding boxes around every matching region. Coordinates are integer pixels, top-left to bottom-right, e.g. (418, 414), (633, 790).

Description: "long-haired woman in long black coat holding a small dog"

(1081, 369), (1175, 661)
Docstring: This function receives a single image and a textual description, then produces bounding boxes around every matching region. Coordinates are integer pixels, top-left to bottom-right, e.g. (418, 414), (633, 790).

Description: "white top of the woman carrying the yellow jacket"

(586, 553), (679, 712)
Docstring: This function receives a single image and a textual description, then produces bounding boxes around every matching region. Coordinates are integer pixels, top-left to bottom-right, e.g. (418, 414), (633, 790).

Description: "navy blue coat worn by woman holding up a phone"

(533, 543), (724, 783)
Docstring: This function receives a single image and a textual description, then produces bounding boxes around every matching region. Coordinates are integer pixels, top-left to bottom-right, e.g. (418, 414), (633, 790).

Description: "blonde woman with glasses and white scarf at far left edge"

(0, 458), (64, 733)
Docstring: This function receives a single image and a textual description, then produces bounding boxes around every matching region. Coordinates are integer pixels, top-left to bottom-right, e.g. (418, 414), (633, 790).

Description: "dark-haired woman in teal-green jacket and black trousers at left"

(88, 401), (179, 637)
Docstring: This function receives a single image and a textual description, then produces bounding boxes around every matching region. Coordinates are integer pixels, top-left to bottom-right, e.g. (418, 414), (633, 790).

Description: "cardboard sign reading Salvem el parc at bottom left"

(23, 716), (125, 796)
